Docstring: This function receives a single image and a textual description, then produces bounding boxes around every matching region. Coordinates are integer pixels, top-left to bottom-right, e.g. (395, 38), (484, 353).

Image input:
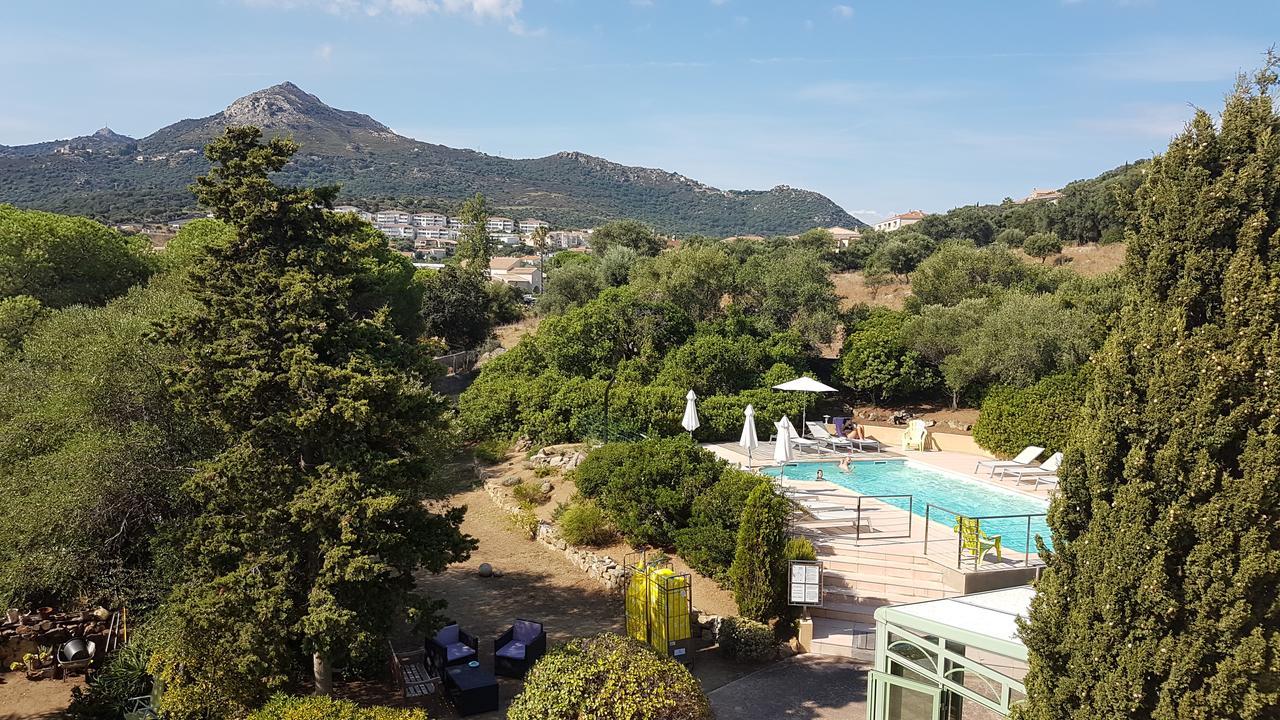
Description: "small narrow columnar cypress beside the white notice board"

(730, 483), (792, 623)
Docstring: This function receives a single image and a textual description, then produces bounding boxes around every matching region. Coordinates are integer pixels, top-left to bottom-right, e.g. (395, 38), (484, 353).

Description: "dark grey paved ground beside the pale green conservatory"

(709, 655), (869, 720)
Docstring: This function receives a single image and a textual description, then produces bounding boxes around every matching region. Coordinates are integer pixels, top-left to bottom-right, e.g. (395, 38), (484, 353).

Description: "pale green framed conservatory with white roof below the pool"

(867, 587), (1034, 720)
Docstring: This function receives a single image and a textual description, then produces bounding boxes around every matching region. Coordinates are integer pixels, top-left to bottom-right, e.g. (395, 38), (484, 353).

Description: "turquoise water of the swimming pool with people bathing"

(760, 460), (1052, 552)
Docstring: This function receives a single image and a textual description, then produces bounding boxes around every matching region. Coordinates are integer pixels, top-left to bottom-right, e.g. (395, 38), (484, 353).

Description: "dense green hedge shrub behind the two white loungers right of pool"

(973, 365), (1089, 456)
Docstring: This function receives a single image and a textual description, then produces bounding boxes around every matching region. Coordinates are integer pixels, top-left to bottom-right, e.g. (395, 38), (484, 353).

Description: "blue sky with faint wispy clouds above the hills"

(0, 0), (1280, 222)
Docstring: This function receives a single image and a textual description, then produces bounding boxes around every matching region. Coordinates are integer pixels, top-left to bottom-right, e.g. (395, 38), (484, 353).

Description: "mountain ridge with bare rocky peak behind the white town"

(0, 82), (864, 234)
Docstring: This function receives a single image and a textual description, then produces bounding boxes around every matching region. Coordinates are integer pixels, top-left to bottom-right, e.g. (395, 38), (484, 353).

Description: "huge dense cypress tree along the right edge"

(1019, 56), (1280, 720)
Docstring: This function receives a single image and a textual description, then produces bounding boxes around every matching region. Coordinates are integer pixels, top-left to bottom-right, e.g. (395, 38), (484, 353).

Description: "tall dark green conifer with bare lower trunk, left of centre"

(152, 127), (472, 716)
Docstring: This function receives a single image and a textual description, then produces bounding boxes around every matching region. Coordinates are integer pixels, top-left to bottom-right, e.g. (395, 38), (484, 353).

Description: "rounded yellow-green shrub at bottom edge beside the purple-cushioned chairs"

(507, 633), (714, 720)
